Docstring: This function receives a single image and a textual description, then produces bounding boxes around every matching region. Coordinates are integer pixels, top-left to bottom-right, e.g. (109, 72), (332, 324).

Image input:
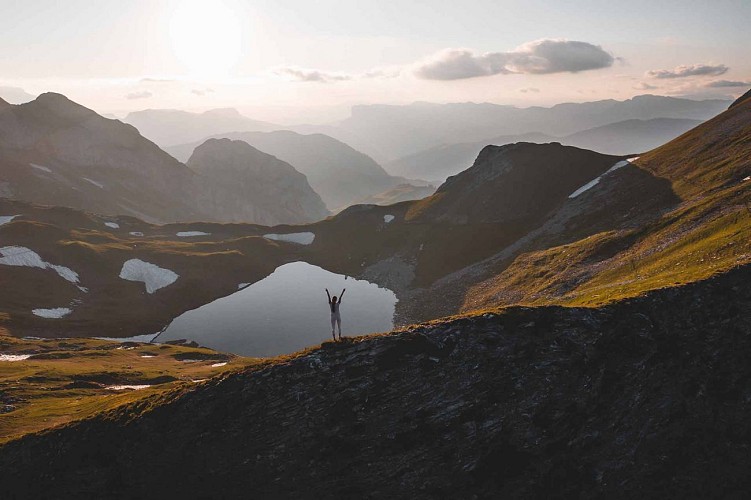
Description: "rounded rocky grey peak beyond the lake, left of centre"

(186, 139), (328, 226)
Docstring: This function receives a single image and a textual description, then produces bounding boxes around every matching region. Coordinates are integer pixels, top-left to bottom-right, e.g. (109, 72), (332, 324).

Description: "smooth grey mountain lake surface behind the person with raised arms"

(157, 262), (397, 356)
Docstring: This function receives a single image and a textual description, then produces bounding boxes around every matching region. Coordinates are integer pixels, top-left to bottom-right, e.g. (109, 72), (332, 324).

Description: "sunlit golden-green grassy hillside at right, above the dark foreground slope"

(462, 97), (751, 310)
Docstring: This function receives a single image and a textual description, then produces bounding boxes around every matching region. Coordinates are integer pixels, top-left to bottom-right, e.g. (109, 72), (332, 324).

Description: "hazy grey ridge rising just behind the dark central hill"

(386, 118), (701, 181)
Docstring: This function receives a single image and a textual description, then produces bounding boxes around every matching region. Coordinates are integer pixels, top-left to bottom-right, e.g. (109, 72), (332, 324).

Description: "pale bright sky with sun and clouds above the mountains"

(0, 0), (751, 124)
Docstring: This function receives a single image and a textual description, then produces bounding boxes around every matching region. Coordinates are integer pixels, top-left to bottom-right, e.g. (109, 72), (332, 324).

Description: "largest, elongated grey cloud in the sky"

(415, 39), (615, 80)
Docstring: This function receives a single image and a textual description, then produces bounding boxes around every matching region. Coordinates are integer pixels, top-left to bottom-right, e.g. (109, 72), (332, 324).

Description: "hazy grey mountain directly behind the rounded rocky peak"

(166, 130), (412, 210)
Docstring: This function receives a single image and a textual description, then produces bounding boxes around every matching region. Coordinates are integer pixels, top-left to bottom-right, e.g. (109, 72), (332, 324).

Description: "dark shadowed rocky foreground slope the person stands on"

(0, 266), (751, 498)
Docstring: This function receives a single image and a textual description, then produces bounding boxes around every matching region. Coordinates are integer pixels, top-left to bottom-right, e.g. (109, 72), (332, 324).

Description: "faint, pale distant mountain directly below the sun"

(123, 108), (279, 146)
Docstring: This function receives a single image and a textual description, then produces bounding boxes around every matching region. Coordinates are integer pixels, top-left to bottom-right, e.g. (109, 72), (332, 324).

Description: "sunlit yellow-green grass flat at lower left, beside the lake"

(0, 329), (260, 443)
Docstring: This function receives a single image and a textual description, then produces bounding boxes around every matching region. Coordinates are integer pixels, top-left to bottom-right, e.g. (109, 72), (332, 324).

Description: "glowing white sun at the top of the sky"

(170, 0), (242, 78)
